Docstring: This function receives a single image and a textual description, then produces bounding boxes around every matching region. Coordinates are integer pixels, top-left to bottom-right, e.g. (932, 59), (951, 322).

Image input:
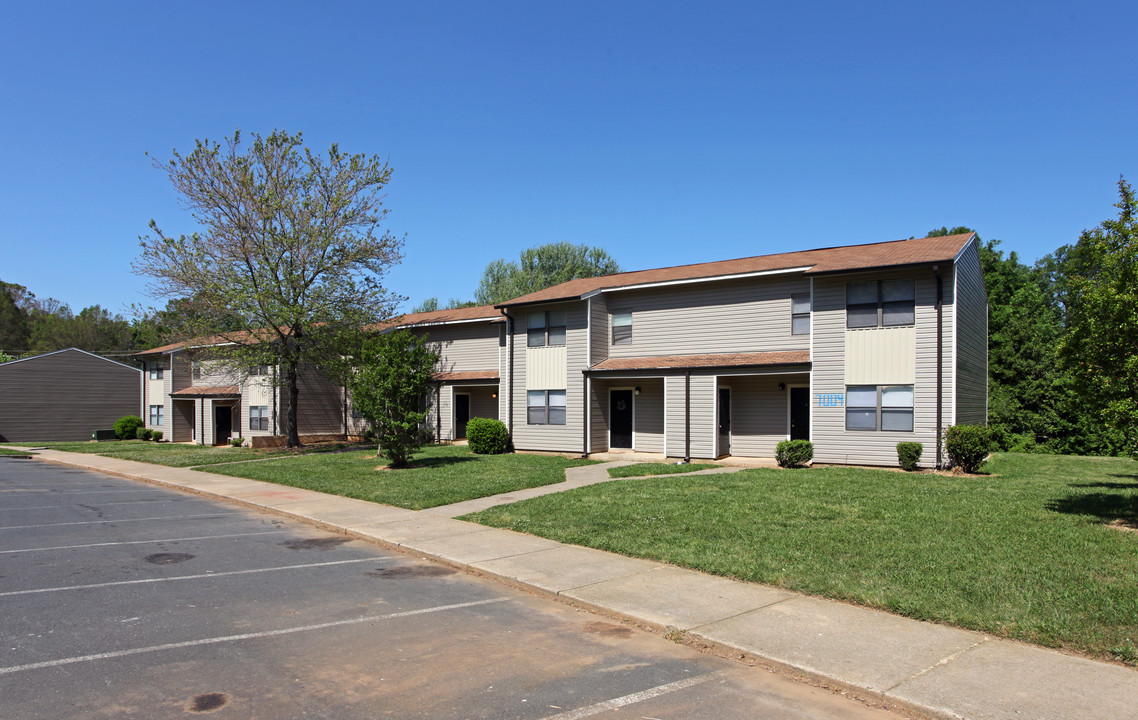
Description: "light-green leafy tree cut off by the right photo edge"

(1062, 179), (1138, 458)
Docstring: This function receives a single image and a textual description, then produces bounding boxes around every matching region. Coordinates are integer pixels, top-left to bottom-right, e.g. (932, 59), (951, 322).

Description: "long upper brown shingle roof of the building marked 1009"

(496, 232), (975, 307)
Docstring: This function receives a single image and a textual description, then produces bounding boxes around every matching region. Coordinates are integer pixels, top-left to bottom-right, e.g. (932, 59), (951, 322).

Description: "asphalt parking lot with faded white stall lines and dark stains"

(0, 458), (898, 720)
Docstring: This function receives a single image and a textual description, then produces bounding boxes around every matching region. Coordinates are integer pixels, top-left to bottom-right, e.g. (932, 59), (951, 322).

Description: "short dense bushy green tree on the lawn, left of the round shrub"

(351, 330), (438, 467)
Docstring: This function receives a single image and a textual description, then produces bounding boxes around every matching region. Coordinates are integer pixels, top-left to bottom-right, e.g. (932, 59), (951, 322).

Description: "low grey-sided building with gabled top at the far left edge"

(0, 349), (142, 442)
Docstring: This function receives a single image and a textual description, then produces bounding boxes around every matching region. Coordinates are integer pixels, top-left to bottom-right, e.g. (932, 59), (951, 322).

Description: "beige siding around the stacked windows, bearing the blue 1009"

(810, 267), (953, 466)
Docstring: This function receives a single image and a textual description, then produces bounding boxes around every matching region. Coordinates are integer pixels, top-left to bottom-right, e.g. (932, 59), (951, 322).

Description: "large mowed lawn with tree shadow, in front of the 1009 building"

(464, 454), (1138, 664)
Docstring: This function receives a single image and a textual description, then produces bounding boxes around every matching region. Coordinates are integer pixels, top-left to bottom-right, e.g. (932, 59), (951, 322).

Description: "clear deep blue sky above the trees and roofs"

(0, 0), (1138, 312)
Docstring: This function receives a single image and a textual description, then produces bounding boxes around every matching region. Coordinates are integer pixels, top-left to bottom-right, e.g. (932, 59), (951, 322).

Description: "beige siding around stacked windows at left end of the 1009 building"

(514, 300), (588, 453)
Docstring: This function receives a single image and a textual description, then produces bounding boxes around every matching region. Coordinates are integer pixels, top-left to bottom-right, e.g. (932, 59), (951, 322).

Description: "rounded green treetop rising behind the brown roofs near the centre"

(475, 242), (620, 305)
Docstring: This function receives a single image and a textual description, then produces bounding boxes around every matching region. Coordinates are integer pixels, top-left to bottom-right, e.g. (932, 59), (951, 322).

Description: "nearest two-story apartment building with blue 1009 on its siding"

(496, 233), (988, 465)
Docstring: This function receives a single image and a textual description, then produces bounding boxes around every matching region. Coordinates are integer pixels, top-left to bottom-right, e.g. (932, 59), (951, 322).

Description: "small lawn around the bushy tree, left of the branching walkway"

(208, 445), (591, 510)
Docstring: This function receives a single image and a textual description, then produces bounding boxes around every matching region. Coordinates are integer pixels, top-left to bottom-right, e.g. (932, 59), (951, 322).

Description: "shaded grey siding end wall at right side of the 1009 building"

(955, 240), (988, 425)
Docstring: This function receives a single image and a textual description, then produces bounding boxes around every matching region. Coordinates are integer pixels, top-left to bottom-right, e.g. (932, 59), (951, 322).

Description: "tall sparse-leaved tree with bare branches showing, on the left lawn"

(134, 130), (403, 447)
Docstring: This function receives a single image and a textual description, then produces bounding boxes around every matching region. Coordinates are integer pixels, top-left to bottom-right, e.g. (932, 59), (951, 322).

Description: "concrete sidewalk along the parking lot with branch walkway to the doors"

(17, 450), (1138, 720)
